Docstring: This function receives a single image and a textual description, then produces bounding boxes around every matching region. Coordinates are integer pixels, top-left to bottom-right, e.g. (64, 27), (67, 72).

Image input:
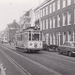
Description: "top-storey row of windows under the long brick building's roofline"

(35, 0), (75, 19)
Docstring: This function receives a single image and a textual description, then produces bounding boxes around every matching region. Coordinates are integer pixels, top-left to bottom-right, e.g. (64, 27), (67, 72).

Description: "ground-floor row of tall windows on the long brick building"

(45, 31), (75, 45)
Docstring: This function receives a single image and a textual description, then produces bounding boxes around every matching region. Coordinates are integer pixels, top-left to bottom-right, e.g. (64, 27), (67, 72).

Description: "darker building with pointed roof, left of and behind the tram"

(6, 20), (20, 42)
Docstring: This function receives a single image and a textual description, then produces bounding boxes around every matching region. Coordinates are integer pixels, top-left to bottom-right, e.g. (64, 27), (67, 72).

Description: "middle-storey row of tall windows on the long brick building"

(40, 9), (75, 30)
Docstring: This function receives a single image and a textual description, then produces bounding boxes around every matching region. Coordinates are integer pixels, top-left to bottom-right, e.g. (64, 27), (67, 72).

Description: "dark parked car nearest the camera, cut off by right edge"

(58, 41), (75, 56)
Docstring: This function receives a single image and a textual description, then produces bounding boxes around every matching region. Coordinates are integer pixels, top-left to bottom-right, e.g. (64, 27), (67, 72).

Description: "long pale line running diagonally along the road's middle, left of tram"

(3, 46), (62, 75)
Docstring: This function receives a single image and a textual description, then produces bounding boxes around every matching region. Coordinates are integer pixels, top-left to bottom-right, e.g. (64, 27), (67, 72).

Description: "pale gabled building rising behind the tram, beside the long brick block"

(20, 9), (35, 29)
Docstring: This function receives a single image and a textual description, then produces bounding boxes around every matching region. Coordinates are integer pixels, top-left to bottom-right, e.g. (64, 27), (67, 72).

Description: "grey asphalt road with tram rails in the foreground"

(0, 45), (75, 75)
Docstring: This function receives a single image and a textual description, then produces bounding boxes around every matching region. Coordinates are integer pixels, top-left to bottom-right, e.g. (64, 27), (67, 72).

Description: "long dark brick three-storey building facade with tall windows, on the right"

(35, 0), (75, 45)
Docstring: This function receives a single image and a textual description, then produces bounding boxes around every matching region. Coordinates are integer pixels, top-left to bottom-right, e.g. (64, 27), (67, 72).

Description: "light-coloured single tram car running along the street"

(15, 28), (43, 52)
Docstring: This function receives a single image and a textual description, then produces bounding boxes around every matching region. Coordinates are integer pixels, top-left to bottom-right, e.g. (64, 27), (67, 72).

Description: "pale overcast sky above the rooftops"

(0, 0), (44, 31)
